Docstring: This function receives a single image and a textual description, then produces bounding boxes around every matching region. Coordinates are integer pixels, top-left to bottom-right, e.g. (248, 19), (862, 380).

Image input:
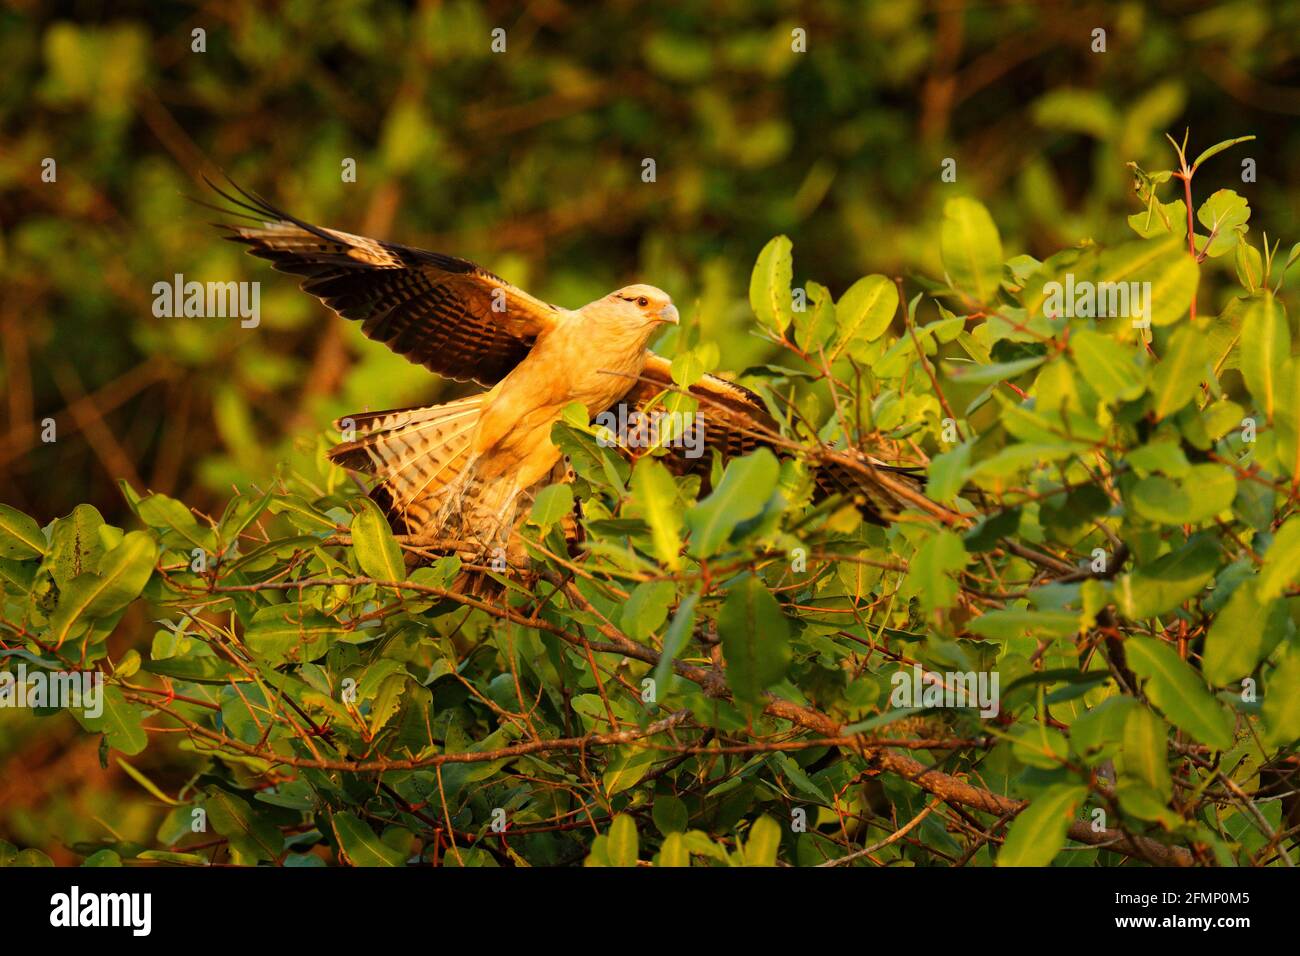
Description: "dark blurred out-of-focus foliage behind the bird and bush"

(0, 0), (1300, 860)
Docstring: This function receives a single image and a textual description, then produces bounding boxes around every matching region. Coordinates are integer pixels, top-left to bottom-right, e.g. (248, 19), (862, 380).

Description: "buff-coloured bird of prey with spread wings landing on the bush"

(215, 187), (920, 558)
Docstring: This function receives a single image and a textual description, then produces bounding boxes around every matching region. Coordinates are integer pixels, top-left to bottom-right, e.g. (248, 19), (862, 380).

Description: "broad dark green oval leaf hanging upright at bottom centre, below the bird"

(718, 574), (792, 704)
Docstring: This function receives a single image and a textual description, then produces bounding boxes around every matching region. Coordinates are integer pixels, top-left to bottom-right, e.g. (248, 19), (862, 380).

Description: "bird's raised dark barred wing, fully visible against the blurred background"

(209, 183), (562, 386)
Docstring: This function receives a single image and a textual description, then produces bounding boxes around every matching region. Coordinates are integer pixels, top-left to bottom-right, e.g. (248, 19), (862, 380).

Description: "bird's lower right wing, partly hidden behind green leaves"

(623, 352), (926, 524)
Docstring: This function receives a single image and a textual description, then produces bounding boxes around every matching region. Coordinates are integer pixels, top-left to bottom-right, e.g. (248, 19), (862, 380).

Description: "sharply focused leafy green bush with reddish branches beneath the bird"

(0, 130), (1300, 865)
